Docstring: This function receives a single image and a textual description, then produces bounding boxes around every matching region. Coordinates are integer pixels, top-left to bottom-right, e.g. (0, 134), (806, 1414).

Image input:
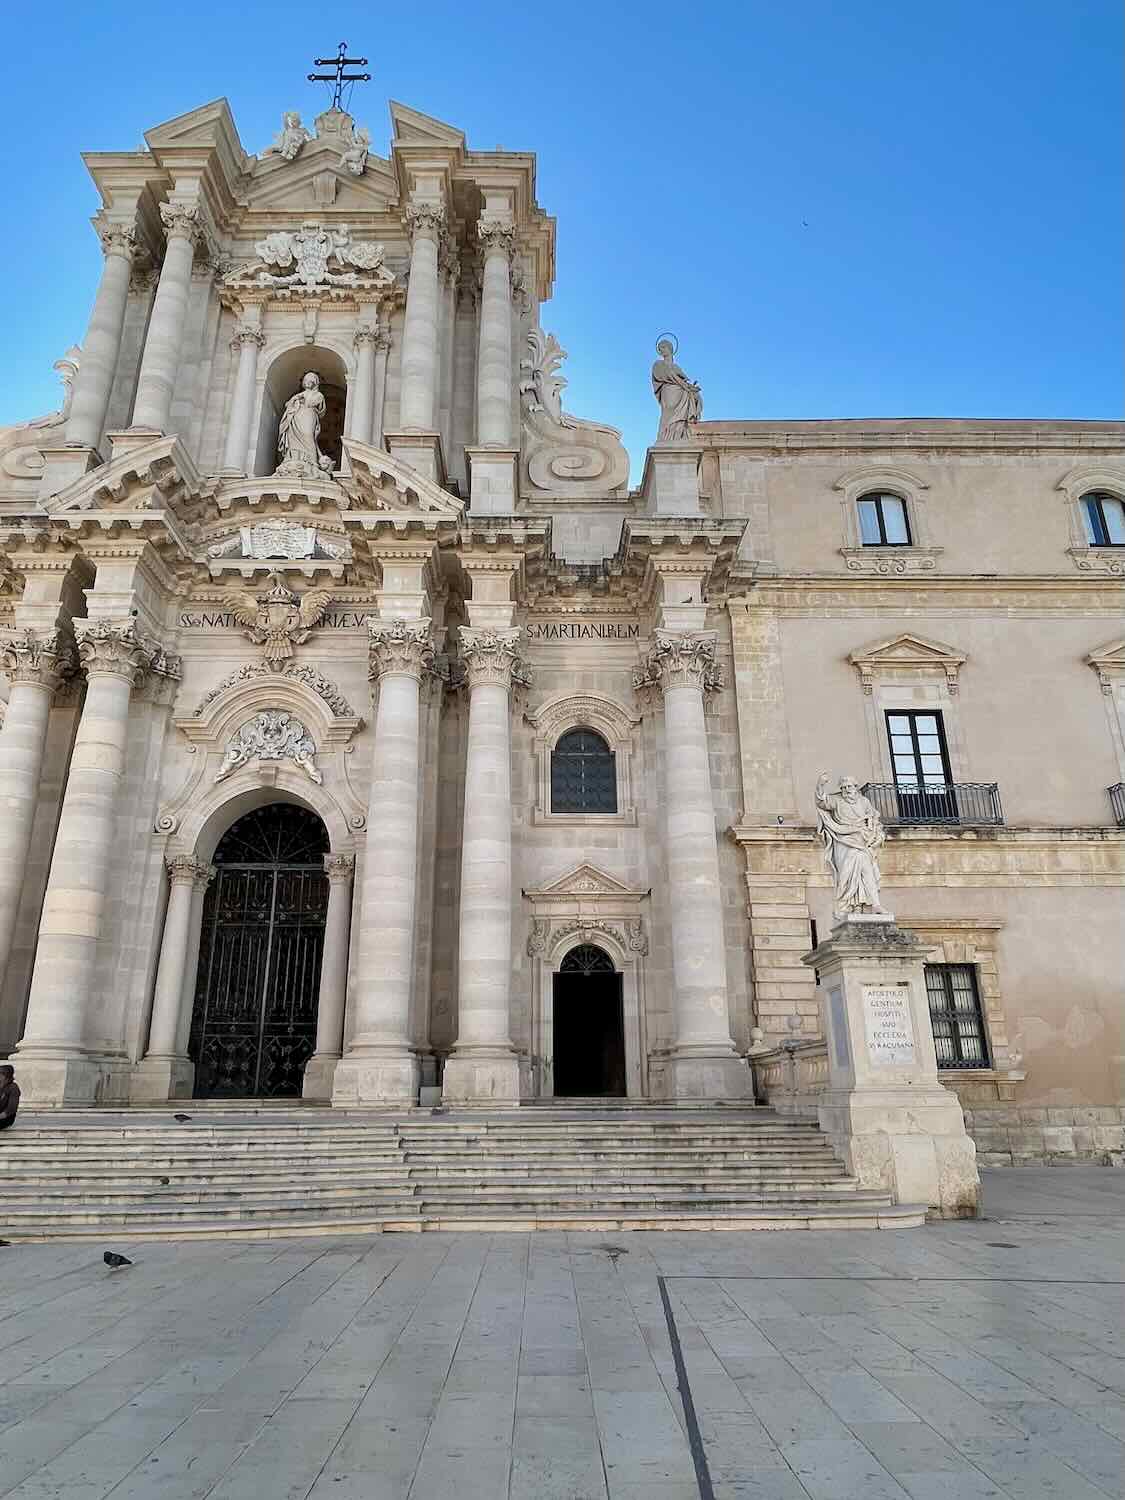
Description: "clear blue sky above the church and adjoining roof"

(0, 0), (1122, 483)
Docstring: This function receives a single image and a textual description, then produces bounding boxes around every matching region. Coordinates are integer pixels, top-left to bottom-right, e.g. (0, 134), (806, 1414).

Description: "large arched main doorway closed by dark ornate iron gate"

(188, 803), (329, 1098)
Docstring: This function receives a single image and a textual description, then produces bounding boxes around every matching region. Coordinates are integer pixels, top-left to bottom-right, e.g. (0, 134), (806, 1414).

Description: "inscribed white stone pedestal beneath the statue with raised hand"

(804, 917), (980, 1218)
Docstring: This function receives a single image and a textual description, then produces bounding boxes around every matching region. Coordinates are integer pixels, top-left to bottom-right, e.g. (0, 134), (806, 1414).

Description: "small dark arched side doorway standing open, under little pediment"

(552, 944), (636, 1100)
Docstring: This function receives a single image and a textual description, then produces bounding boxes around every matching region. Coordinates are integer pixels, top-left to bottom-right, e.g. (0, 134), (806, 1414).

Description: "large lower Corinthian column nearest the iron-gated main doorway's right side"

(332, 620), (434, 1104)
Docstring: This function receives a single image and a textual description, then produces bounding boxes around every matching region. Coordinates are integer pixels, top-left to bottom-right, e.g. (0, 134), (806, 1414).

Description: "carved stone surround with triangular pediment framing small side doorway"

(524, 864), (650, 1100)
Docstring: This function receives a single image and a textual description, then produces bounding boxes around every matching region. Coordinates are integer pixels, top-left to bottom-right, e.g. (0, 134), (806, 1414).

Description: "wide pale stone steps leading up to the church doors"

(0, 1100), (926, 1241)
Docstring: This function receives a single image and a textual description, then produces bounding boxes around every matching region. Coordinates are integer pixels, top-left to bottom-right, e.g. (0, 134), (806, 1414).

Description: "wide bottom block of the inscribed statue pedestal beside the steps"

(818, 1085), (981, 1218)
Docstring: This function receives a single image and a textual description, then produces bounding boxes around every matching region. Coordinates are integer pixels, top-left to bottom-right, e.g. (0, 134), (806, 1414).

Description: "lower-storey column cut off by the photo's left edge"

(0, 630), (71, 983)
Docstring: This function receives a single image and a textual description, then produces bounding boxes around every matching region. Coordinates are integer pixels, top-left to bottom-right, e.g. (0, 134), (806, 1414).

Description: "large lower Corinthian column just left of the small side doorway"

(443, 626), (527, 1104)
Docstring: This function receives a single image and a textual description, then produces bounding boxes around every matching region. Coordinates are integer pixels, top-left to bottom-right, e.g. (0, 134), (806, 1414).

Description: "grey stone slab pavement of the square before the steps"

(0, 1170), (1125, 1500)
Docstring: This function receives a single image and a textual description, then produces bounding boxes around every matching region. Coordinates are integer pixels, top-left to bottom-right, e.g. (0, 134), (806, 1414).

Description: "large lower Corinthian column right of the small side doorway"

(642, 630), (749, 1100)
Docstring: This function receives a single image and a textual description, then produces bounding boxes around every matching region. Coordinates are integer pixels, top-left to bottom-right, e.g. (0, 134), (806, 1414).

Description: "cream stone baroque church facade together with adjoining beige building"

(0, 101), (1125, 1160)
